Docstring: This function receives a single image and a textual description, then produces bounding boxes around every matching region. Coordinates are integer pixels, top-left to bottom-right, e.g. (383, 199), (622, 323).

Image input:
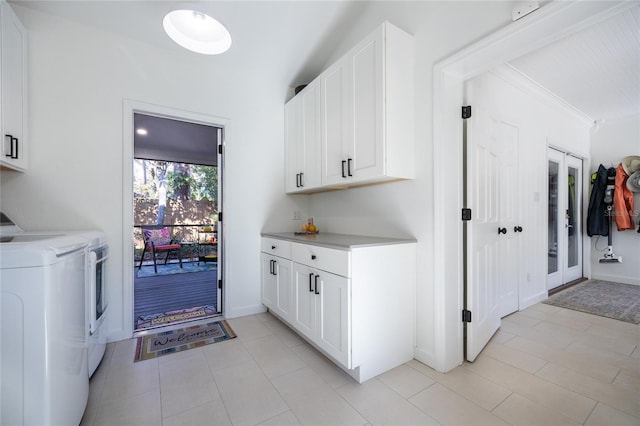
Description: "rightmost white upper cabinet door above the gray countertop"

(347, 31), (385, 182)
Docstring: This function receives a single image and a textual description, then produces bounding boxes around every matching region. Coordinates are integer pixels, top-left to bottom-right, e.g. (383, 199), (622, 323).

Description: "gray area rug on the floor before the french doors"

(542, 280), (640, 324)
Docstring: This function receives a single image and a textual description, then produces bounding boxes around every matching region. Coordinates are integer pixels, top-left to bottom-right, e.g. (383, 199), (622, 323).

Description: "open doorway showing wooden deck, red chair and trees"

(132, 112), (223, 332)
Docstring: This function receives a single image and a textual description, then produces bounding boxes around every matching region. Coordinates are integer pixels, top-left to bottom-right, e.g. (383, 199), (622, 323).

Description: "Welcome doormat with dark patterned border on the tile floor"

(134, 320), (236, 362)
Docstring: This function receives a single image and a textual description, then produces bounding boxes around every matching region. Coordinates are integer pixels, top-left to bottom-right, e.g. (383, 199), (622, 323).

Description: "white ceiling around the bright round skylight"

(9, 0), (368, 87)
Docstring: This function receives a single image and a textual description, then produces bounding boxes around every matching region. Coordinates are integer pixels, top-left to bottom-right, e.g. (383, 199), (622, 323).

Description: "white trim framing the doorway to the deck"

(120, 99), (231, 341)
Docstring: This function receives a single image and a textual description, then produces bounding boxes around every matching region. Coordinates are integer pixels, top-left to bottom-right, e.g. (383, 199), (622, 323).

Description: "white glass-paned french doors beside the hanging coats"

(547, 148), (582, 290)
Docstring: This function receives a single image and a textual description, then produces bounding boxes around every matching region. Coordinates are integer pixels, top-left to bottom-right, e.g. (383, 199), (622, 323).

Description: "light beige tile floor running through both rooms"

(82, 304), (640, 426)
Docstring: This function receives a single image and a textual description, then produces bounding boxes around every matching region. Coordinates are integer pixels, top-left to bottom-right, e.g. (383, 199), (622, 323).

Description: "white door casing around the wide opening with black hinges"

(428, 1), (635, 371)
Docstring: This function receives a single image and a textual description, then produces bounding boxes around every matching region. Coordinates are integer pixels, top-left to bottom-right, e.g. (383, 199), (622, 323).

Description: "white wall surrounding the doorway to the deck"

(0, 7), (306, 339)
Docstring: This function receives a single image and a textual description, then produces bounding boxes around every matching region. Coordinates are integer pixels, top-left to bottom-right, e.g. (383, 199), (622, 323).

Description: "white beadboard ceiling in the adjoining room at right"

(510, 2), (640, 122)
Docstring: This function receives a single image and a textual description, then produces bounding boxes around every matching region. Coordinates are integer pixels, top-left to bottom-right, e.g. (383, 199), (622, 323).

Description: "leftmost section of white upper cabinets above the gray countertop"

(285, 81), (321, 193)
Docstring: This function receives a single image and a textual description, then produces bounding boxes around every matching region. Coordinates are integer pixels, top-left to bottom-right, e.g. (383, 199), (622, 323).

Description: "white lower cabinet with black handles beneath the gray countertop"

(262, 234), (416, 383)
